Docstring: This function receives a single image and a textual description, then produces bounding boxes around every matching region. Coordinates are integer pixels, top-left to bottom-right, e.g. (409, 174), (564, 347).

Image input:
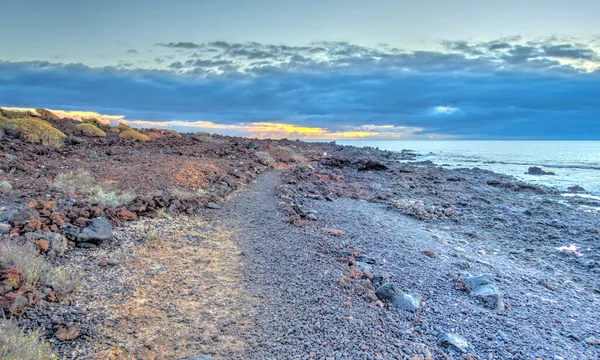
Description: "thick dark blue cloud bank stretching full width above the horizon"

(0, 58), (600, 140)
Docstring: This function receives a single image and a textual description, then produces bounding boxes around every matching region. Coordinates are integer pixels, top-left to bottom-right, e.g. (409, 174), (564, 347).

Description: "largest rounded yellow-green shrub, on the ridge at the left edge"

(0, 117), (67, 148)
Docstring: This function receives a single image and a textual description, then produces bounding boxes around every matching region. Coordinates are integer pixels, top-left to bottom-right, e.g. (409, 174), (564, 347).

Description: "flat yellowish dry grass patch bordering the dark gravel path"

(100, 217), (256, 359)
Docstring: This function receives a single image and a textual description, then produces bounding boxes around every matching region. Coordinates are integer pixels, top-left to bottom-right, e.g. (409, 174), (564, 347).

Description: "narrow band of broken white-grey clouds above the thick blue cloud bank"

(146, 36), (599, 75)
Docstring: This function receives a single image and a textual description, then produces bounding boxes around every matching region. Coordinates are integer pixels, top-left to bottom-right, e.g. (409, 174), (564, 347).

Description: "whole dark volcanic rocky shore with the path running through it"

(0, 111), (600, 360)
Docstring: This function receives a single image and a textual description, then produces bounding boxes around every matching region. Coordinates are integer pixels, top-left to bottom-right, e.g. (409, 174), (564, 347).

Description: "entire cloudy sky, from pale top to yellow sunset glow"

(0, 0), (600, 140)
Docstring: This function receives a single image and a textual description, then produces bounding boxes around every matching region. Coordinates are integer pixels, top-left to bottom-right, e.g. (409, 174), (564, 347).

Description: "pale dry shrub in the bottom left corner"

(0, 319), (58, 360)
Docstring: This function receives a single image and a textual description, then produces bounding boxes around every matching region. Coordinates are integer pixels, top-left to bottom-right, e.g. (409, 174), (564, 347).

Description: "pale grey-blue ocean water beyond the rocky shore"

(336, 140), (600, 200)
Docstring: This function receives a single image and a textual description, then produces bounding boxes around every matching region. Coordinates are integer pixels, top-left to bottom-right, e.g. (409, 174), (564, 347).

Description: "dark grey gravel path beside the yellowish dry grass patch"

(214, 172), (440, 359)
